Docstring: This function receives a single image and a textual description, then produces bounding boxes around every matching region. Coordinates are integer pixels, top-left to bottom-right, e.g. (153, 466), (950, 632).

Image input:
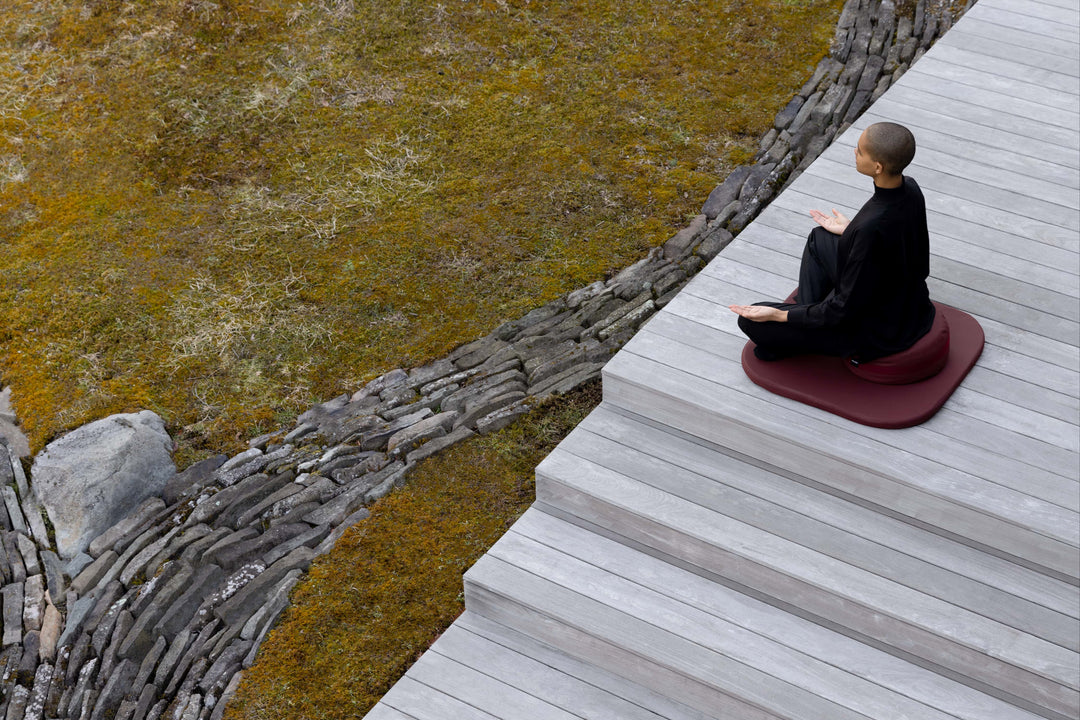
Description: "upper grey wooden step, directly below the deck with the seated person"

(537, 406), (1080, 717)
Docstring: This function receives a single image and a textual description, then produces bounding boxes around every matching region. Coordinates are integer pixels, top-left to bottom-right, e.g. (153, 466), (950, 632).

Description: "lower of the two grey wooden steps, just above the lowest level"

(465, 508), (1052, 720)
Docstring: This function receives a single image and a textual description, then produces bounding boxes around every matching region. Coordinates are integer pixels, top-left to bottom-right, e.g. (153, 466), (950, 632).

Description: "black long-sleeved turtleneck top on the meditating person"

(787, 177), (934, 359)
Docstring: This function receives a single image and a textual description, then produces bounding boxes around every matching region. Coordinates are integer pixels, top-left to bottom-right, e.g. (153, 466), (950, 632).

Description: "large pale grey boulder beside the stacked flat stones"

(30, 410), (176, 558)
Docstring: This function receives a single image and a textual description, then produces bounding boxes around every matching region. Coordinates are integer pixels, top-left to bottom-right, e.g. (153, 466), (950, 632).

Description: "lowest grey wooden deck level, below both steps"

(367, 611), (710, 720)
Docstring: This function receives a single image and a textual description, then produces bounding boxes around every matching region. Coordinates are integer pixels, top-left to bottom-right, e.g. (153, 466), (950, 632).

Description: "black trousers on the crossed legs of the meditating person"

(739, 227), (859, 359)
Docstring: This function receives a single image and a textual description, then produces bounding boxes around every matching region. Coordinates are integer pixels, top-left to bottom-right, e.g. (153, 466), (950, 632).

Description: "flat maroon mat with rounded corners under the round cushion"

(742, 302), (984, 427)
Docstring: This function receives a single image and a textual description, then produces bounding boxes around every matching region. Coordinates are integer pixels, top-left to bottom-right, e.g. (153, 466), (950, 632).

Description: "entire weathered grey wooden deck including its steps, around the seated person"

(367, 0), (1080, 720)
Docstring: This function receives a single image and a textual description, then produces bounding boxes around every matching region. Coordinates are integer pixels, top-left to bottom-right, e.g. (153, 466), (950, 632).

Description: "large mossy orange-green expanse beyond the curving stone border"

(0, 0), (840, 462)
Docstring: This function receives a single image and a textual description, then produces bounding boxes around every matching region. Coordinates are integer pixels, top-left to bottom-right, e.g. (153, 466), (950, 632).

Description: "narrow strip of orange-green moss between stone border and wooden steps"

(225, 381), (600, 720)
